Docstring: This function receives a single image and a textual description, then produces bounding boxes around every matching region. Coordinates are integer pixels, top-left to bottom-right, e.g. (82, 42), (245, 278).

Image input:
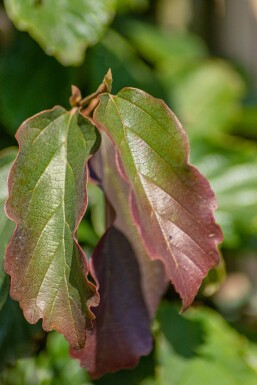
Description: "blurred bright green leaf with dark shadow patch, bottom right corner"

(156, 303), (257, 385)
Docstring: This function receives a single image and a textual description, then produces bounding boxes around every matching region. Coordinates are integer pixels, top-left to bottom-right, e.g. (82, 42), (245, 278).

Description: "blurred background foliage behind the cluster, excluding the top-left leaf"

(0, 0), (257, 385)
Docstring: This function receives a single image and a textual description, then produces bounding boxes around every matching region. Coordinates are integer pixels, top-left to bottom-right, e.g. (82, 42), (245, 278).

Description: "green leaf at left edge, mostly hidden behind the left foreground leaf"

(0, 148), (17, 310)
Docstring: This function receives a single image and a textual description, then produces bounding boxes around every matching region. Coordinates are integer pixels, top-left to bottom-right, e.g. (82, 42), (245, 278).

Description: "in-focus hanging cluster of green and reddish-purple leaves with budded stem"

(5, 71), (222, 377)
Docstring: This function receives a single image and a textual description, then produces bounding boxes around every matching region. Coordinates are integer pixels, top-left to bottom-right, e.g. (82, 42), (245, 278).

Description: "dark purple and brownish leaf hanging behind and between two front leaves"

(72, 132), (167, 378)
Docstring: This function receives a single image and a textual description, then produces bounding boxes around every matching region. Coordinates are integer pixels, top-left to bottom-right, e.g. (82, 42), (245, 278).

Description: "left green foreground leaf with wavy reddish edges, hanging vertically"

(5, 107), (99, 348)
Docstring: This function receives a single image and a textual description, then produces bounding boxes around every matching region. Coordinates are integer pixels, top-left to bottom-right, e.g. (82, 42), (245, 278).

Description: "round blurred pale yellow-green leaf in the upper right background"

(170, 60), (245, 137)
